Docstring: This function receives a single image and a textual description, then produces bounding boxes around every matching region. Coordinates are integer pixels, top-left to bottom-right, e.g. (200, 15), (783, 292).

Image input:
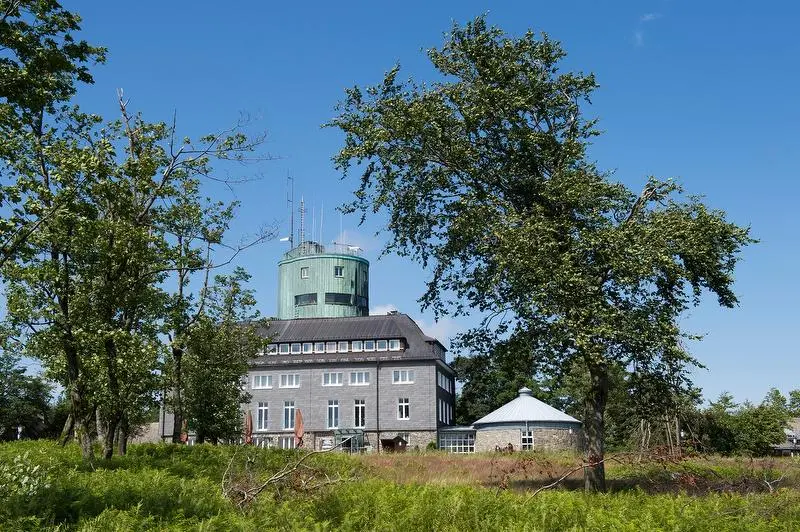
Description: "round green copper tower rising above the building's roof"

(278, 241), (369, 320)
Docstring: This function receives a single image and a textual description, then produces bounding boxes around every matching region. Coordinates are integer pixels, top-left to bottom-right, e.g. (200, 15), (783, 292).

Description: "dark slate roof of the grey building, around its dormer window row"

(254, 313), (445, 366)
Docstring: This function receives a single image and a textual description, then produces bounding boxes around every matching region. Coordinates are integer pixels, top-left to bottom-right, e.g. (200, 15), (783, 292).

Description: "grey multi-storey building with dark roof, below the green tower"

(244, 313), (455, 451)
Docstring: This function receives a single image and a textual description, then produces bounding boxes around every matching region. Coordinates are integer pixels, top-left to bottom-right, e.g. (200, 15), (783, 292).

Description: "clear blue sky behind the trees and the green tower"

(70, 0), (800, 401)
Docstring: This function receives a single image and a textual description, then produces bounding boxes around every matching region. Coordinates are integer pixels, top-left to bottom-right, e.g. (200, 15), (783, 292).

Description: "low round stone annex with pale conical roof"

(473, 388), (584, 452)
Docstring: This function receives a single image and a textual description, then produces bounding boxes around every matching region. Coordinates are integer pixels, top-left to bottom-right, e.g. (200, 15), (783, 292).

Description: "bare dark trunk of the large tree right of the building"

(584, 364), (608, 492)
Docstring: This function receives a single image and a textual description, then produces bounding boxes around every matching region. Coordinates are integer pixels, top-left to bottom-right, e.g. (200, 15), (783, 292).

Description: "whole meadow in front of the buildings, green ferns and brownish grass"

(0, 441), (800, 532)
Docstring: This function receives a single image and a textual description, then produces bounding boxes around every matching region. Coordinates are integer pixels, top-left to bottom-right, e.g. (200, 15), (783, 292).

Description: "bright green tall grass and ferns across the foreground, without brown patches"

(0, 442), (800, 531)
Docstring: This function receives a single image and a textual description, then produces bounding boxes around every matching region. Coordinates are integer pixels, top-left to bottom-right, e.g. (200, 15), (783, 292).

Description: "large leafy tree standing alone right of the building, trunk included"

(329, 17), (752, 490)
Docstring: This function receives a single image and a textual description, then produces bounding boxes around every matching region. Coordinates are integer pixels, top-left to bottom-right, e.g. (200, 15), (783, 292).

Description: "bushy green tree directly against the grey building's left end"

(184, 268), (264, 444)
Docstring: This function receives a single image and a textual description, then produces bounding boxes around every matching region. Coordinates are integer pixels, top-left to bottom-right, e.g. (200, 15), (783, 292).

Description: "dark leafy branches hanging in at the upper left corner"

(0, 0), (105, 264)
